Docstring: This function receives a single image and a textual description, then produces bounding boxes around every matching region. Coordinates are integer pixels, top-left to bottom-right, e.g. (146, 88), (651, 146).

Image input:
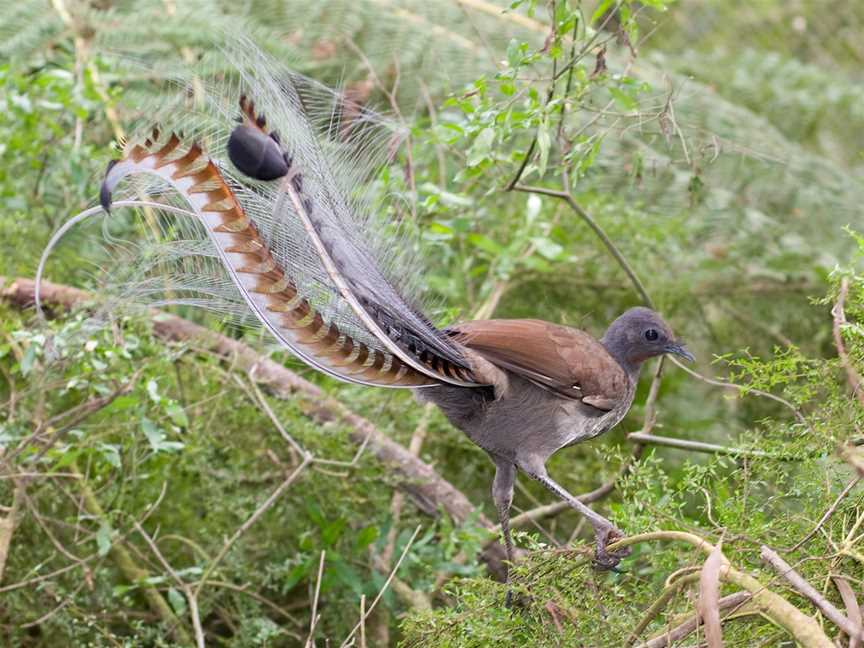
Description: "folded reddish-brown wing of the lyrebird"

(448, 319), (628, 410)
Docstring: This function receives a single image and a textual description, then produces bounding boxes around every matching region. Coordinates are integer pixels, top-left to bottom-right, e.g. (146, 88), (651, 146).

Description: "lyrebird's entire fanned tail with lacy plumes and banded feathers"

(42, 42), (486, 387)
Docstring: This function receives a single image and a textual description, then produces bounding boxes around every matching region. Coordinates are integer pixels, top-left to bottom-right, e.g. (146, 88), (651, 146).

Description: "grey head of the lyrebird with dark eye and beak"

(601, 306), (694, 374)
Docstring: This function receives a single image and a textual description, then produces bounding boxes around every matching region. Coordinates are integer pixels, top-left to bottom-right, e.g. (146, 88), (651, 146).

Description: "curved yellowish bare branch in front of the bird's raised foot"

(600, 531), (834, 648)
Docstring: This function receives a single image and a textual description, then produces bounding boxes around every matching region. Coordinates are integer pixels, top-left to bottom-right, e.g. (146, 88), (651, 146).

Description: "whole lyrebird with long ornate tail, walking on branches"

(40, 46), (692, 604)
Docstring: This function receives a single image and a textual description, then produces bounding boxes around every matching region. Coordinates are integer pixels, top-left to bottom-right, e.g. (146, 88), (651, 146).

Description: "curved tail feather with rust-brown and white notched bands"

(100, 131), (448, 387)
